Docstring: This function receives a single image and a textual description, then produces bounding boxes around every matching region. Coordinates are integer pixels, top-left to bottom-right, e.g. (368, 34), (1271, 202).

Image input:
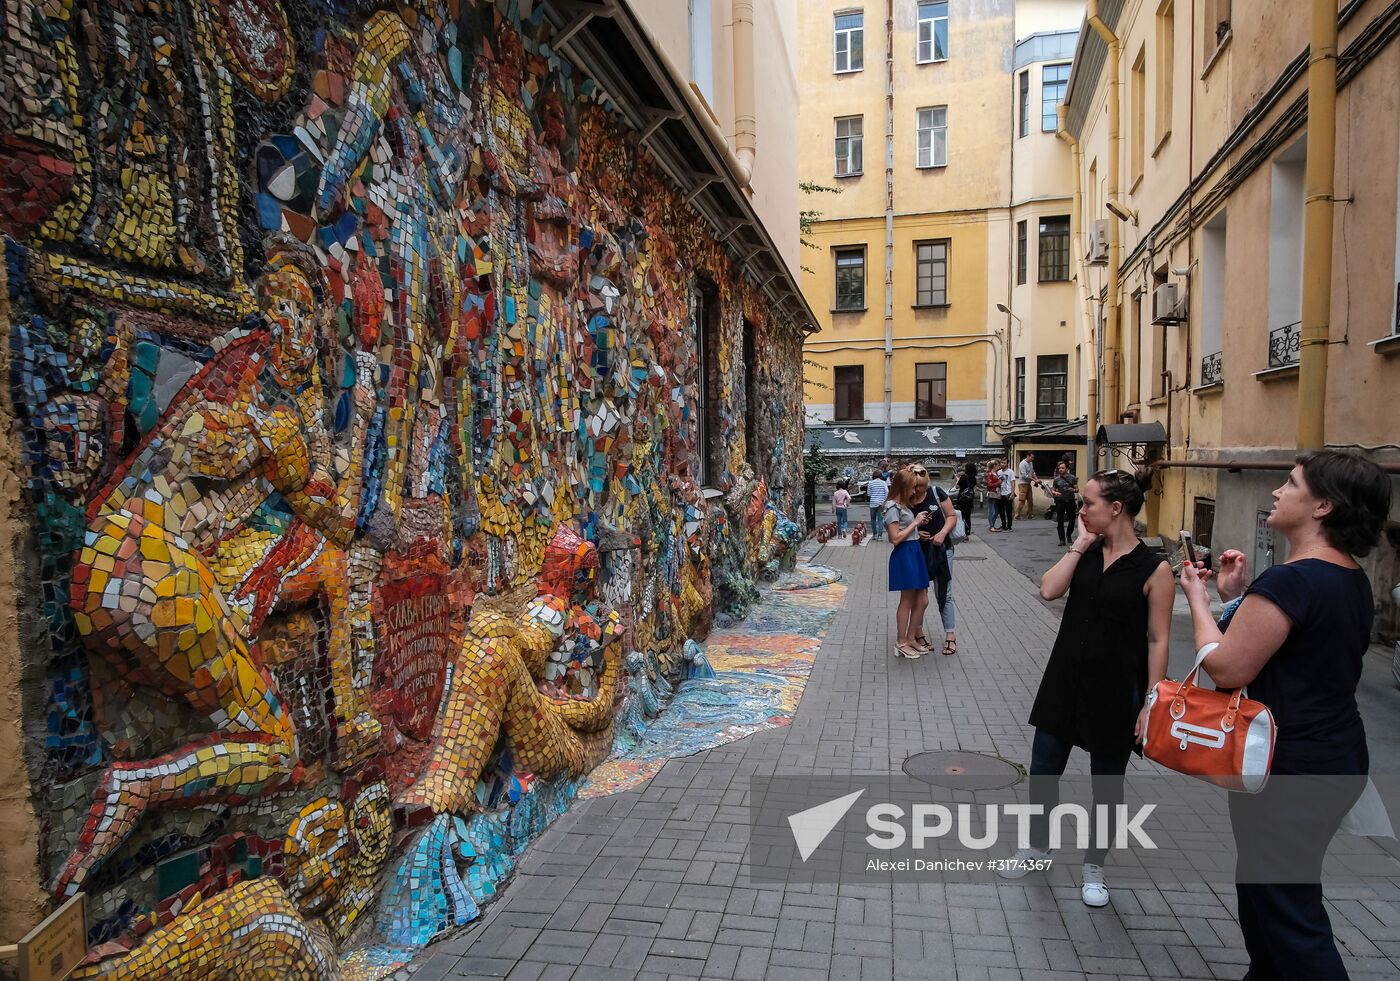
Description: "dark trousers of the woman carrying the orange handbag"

(1229, 744), (1369, 981)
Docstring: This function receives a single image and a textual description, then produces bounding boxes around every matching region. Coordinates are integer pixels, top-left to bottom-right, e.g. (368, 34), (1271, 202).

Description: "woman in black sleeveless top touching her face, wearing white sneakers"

(1001, 470), (1176, 905)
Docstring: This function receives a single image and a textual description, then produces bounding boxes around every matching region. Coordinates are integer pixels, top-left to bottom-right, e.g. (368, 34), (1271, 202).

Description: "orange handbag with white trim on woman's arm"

(1142, 644), (1278, 793)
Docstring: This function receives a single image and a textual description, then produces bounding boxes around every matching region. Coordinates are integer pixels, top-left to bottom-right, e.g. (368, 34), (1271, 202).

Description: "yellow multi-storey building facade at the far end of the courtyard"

(798, 0), (1082, 487)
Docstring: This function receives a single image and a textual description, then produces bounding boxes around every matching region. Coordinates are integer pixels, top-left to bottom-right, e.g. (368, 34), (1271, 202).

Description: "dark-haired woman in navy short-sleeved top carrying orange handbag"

(1182, 451), (1390, 981)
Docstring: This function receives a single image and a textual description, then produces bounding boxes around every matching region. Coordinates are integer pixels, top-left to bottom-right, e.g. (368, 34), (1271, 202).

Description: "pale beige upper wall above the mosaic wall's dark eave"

(629, 0), (801, 274)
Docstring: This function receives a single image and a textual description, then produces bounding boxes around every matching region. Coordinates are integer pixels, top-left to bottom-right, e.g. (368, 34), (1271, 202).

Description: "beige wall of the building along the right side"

(1072, 0), (1400, 565)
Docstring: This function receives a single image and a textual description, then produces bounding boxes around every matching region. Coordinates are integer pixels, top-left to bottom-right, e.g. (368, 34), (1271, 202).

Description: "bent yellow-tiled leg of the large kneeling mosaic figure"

(55, 512), (298, 896)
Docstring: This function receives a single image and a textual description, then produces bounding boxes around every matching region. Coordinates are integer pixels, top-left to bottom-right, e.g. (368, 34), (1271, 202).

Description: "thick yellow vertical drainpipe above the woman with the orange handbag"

(1298, 0), (1337, 449)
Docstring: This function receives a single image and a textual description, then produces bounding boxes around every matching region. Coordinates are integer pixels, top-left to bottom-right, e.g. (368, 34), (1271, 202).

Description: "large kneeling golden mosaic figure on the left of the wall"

(55, 244), (374, 896)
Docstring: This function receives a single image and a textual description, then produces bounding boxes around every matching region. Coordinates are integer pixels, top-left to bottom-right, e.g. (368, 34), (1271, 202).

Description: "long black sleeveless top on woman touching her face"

(1030, 540), (1166, 757)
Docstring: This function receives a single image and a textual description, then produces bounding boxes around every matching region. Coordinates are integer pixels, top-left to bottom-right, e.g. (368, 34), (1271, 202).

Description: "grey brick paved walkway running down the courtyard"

(414, 542), (1400, 981)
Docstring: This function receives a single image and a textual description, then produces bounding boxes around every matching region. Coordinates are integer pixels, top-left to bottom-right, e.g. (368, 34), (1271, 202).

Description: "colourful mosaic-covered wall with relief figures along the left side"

(0, 0), (802, 978)
